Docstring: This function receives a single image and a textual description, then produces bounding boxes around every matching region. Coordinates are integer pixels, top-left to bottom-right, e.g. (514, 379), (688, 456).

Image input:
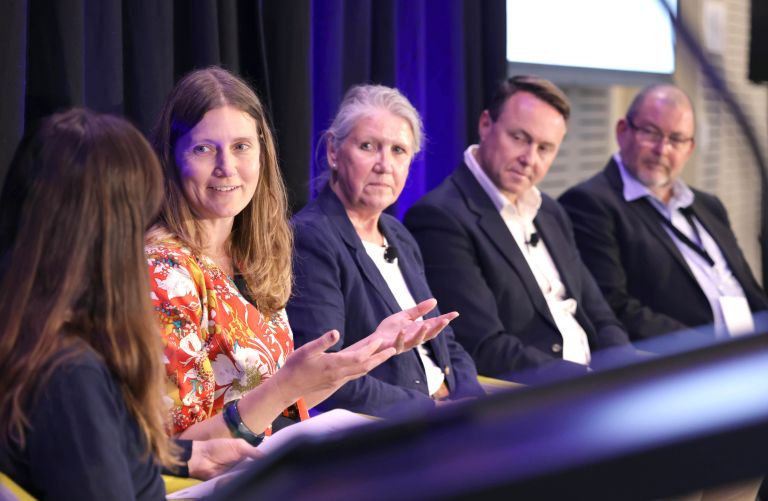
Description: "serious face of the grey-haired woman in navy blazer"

(328, 109), (414, 215)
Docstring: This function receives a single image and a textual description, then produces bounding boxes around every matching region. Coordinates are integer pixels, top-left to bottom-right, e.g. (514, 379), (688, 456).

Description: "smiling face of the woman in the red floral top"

(175, 106), (261, 224)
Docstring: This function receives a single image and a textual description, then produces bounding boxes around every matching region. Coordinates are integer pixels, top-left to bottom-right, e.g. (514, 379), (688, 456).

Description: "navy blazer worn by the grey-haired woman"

(287, 186), (483, 415)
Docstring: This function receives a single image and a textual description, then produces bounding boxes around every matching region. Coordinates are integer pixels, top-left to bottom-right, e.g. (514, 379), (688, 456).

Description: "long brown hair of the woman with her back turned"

(0, 109), (178, 466)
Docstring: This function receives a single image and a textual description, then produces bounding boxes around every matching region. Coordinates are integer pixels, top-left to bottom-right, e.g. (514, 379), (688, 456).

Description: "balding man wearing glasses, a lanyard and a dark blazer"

(560, 84), (768, 341)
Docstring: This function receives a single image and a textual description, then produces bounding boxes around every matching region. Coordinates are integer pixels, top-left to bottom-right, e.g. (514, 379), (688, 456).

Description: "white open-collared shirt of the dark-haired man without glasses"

(464, 145), (591, 365)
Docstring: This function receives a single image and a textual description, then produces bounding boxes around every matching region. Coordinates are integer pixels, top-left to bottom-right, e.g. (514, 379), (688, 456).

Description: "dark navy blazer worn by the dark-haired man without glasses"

(404, 164), (629, 376)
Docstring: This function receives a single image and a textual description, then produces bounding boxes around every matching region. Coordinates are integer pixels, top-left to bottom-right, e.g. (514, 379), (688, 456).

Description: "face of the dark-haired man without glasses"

(476, 91), (566, 203)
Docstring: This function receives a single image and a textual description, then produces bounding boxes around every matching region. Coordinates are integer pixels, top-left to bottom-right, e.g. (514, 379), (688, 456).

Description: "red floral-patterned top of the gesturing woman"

(146, 242), (307, 433)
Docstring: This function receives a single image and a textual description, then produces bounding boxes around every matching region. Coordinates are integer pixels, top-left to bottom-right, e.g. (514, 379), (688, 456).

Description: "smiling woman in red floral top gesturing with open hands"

(146, 68), (453, 443)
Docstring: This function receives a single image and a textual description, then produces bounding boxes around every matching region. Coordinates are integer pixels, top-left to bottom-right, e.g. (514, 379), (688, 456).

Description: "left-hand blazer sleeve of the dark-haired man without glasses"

(405, 200), (557, 376)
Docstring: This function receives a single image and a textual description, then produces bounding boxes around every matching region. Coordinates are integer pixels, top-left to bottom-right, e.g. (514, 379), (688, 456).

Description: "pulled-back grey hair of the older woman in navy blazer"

(323, 85), (424, 156)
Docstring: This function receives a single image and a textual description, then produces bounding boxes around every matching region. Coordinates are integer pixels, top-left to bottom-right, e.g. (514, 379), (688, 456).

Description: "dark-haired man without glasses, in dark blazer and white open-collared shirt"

(404, 77), (629, 377)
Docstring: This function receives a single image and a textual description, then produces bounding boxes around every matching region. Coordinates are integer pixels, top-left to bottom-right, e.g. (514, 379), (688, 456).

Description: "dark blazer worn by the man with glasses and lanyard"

(560, 159), (768, 339)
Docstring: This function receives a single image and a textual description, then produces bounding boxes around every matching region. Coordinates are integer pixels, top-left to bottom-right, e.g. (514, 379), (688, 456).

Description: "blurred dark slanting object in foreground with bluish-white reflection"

(207, 328), (768, 500)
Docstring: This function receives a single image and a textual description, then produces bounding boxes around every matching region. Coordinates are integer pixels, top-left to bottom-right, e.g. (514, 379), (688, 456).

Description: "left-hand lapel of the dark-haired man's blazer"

(453, 164), (556, 327)
